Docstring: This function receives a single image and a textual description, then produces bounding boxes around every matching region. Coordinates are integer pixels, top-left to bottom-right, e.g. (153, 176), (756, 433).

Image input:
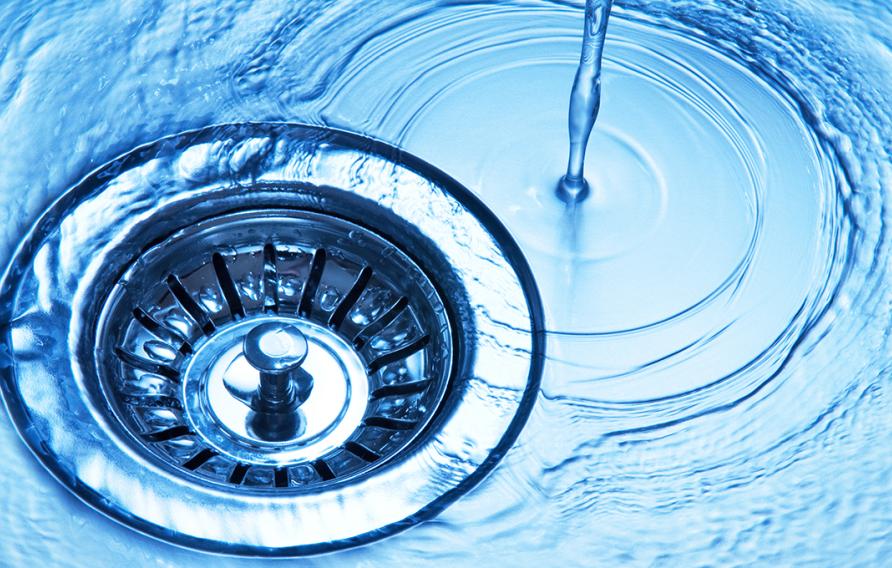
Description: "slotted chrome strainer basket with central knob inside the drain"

(103, 210), (452, 489)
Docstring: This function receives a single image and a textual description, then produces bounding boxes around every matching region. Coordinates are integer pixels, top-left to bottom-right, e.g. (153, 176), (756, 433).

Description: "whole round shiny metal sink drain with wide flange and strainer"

(0, 124), (543, 555)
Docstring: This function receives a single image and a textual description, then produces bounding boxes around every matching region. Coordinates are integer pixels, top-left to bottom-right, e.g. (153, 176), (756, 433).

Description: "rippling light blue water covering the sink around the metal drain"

(0, 0), (892, 566)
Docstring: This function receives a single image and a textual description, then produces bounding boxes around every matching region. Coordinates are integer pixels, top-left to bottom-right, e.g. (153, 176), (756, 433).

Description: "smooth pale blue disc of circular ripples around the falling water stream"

(318, 1), (851, 452)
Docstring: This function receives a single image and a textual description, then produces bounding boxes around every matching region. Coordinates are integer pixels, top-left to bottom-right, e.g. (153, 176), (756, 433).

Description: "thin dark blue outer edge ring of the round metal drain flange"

(0, 123), (545, 556)
